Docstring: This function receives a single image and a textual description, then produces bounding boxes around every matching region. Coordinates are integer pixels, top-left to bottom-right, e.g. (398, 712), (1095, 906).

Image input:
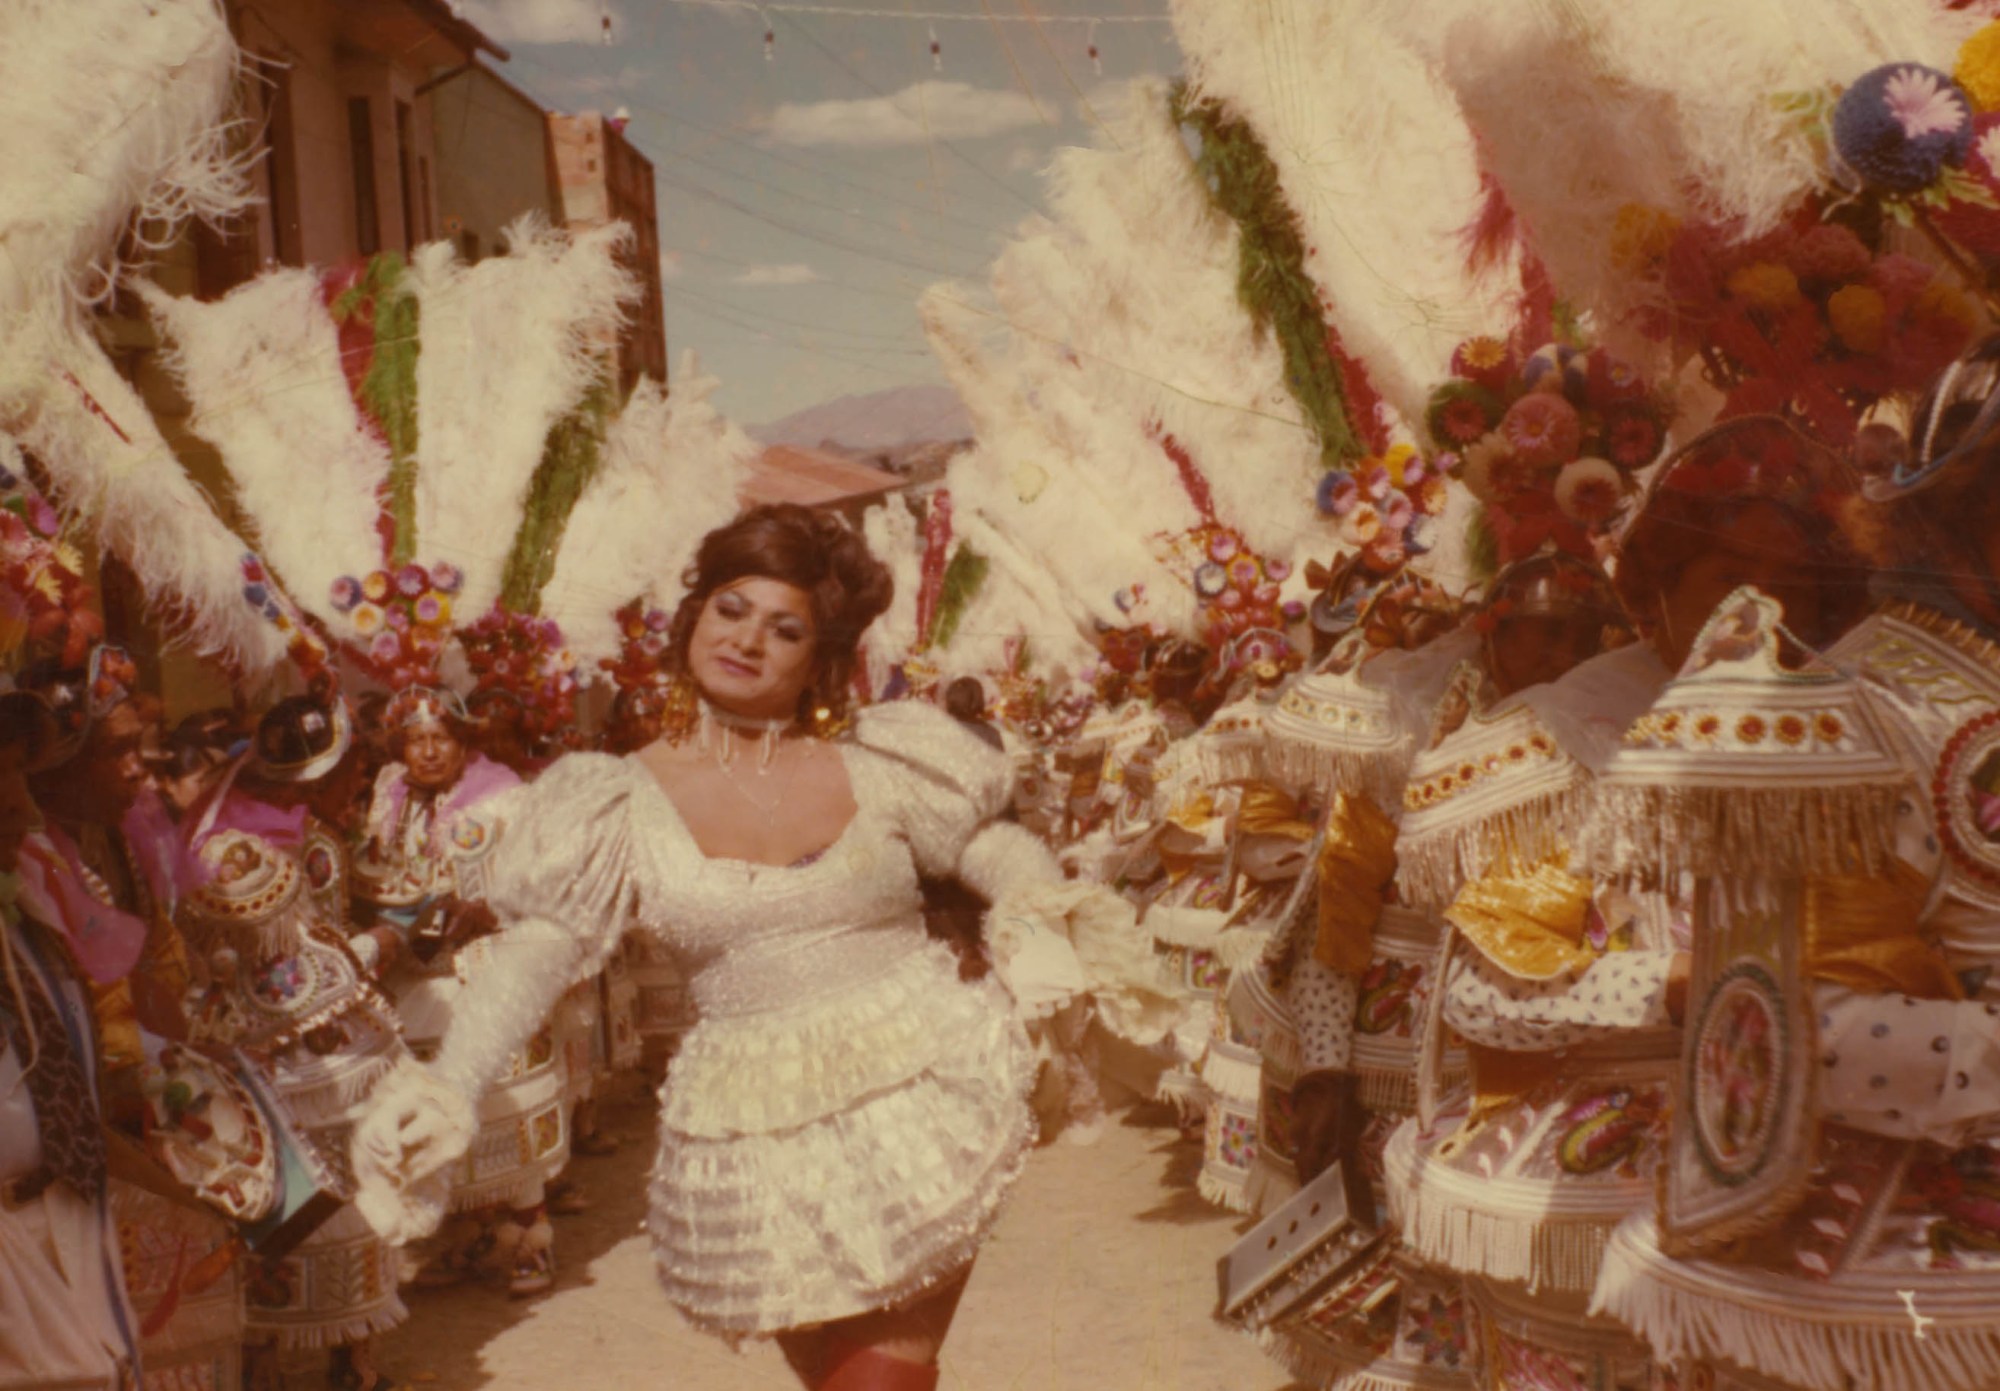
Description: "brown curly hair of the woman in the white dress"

(666, 502), (896, 723)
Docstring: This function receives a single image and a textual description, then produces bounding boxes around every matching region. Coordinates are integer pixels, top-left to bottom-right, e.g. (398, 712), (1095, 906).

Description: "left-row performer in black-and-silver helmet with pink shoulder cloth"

(182, 691), (408, 1391)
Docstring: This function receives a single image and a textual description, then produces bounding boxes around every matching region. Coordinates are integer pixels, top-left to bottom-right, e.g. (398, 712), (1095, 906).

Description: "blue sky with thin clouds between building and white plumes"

(460, 0), (1180, 424)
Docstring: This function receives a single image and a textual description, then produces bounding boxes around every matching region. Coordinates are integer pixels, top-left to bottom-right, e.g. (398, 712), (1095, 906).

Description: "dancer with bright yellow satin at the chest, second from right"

(1382, 552), (1672, 1385)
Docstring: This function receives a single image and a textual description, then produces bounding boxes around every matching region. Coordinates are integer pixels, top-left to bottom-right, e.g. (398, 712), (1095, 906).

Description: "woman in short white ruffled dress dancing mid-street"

(356, 506), (1076, 1391)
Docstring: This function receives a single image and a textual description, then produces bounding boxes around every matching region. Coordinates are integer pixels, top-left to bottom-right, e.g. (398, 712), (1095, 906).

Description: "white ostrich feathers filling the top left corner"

(0, 0), (250, 379)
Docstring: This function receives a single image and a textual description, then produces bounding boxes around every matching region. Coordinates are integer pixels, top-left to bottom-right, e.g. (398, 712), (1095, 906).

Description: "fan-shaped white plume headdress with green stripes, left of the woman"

(148, 220), (754, 696)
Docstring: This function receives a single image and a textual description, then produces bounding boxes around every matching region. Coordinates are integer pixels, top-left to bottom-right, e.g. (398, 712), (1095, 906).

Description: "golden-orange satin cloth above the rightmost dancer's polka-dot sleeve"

(1804, 859), (1964, 999)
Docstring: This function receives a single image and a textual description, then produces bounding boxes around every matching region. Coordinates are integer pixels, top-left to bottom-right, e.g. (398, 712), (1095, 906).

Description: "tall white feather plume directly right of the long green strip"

(1172, 0), (1512, 429)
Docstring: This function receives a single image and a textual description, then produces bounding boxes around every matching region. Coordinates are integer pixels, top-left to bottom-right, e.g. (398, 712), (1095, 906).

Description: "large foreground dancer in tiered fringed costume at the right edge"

(1594, 342), (2000, 1391)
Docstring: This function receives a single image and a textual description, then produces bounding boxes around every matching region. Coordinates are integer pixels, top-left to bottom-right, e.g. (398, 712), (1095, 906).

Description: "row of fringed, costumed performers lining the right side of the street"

(1016, 369), (2000, 1391)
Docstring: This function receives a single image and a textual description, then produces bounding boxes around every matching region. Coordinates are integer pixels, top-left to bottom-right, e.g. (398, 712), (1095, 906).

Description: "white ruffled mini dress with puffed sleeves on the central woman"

(392, 705), (1054, 1335)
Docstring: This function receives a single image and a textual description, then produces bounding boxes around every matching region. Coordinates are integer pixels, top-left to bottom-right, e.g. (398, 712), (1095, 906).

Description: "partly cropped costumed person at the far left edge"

(0, 694), (140, 1391)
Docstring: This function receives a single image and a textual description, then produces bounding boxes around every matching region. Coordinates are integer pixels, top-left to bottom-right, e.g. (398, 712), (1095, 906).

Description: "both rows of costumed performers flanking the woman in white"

(11, 367), (2000, 1391)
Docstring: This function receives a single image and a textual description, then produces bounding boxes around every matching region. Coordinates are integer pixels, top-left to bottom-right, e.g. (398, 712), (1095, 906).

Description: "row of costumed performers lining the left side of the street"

(0, 646), (686, 1387)
